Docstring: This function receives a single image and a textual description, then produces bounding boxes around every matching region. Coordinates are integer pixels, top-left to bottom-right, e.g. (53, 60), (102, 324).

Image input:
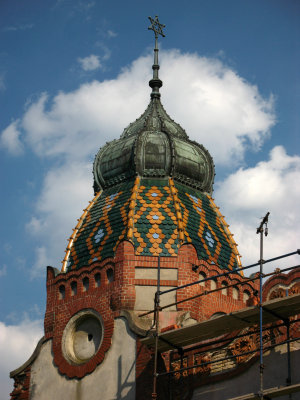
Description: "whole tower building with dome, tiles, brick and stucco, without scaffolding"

(11, 20), (300, 400)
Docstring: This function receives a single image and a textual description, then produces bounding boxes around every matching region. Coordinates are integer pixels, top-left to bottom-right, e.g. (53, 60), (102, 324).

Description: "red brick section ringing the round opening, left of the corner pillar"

(45, 261), (116, 378)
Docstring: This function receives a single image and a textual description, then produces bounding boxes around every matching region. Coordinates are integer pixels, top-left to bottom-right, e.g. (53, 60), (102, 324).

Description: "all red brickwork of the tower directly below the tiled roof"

(45, 241), (257, 378)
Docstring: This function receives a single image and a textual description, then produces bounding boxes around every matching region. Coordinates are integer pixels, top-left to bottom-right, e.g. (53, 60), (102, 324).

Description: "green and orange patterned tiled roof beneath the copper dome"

(63, 177), (239, 270)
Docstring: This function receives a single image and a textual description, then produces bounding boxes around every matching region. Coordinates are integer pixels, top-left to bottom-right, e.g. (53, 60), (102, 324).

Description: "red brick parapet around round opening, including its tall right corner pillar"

(44, 242), (135, 378)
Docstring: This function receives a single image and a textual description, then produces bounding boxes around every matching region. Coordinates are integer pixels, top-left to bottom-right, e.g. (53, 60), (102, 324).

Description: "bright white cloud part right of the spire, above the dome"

(161, 51), (275, 165)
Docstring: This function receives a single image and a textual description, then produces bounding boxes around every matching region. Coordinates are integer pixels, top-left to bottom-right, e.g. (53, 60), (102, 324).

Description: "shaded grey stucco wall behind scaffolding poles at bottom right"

(192, 342), (300, 400)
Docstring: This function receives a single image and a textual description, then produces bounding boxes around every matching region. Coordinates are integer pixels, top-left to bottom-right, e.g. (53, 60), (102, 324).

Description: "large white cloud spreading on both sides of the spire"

(19, 51), (275, 165)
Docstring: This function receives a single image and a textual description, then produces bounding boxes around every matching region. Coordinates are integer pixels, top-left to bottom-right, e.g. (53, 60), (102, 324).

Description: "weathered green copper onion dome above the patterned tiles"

(94, 97), (214, 193)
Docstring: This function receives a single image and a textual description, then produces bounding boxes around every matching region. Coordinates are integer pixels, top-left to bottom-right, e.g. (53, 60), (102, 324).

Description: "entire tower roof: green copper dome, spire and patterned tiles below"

(63, 20), (240, 271)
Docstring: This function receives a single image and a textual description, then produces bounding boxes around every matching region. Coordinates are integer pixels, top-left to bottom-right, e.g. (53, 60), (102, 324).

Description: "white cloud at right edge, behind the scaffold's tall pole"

(215, 146), (300, 270)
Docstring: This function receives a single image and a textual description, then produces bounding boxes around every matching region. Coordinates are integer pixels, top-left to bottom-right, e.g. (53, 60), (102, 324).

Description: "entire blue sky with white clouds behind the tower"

(0, 0), (300, 400)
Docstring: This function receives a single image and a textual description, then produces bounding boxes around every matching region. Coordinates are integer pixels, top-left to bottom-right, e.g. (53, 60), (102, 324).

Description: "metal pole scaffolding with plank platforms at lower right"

(139, 213), (300, 400)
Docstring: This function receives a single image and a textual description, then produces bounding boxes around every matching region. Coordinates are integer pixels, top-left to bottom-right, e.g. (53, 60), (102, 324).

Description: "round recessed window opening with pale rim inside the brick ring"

(62, 310), (103, 364)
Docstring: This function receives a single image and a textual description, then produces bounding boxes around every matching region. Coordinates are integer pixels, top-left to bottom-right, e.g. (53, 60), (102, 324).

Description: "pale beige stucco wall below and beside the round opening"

(30, 318), (136, 400)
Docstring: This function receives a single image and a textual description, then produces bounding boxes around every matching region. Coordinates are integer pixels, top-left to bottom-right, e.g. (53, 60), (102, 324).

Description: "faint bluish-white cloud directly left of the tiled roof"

(27, 162), (93, 277)
